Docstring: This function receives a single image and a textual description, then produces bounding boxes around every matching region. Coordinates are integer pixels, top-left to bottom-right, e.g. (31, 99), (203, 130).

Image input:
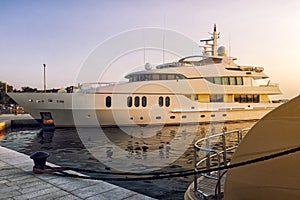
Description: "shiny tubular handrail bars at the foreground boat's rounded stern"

(194, 128), (250, 195)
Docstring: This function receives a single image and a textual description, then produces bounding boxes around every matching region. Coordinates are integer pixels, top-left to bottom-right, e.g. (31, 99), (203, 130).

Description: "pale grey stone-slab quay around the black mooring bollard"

(0, 146), (153, 200)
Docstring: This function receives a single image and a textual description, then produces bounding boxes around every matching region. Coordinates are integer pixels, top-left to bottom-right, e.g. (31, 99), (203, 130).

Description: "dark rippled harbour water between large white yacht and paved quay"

(0, 121), (256, 199)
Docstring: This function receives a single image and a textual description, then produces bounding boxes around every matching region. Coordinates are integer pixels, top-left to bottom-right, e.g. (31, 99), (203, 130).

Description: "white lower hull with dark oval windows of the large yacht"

(9, 93), (279, 127)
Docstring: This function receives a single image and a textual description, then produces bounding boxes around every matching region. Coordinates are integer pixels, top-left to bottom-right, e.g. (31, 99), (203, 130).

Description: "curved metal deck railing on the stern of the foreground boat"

(194, 128), (250, 197)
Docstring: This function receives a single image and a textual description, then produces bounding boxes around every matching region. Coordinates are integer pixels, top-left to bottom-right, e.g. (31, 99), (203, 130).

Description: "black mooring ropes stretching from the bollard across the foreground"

(41, 147), (300, 181)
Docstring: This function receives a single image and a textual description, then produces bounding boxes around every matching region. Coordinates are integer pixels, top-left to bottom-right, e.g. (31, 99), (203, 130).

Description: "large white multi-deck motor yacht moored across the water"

(8, 25), (282, 127)
